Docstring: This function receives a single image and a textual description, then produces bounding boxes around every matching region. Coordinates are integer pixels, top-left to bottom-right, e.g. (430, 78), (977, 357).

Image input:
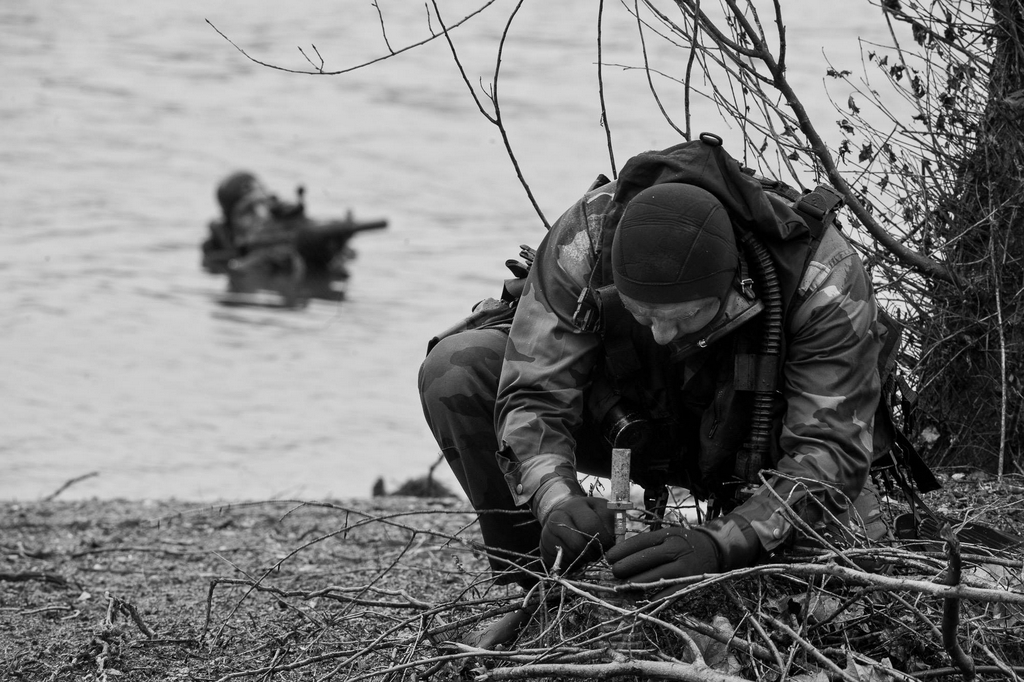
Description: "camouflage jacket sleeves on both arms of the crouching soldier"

(496, 176), (880, 551)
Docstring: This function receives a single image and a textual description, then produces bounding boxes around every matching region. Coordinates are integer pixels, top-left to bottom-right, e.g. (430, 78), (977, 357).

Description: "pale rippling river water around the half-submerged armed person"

(0, 0), (881, 501)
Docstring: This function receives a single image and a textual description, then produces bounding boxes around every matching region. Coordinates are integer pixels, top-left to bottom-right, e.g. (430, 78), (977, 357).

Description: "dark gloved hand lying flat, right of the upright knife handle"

(605, 526), (722, 583)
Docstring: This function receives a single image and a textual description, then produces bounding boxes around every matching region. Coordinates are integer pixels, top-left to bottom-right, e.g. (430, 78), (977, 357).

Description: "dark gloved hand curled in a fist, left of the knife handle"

(541, 497), (615, 573)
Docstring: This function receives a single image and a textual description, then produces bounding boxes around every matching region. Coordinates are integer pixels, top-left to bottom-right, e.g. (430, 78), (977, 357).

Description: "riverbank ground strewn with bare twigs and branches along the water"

(0, 481), (1024, 682)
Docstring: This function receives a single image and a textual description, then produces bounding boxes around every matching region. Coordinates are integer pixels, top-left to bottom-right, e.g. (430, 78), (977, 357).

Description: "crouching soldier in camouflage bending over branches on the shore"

(420, 134), (886, 586)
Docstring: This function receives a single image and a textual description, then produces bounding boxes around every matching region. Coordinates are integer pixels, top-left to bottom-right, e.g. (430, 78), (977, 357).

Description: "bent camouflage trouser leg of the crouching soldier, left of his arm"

(419, 329), (541, 580)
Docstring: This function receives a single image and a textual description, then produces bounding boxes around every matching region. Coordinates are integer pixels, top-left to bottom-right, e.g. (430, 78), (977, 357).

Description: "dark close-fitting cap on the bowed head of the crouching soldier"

(611, 182), (739, 304)
